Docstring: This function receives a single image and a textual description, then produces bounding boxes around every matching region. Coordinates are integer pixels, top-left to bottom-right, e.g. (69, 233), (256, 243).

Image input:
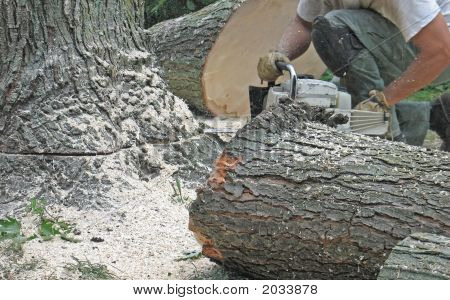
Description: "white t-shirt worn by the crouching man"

(297, 0), (450, 41)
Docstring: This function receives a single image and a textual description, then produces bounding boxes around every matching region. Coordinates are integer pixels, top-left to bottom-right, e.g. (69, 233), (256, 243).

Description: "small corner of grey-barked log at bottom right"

(378, 233), (450, 280)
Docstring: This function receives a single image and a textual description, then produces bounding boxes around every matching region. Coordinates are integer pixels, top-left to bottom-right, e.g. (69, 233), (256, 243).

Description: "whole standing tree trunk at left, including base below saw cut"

(0, 0), (220, 215)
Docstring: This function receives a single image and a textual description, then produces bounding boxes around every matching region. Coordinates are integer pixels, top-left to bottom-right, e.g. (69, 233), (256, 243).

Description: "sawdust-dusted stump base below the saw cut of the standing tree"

(0, 135), (223, 212)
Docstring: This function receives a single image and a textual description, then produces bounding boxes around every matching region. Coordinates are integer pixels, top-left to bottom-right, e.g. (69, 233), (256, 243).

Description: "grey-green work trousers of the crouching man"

(325, 9), (450, 145)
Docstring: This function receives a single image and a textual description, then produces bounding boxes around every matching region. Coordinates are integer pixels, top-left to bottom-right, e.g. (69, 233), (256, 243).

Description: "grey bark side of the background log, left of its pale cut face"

(147, 0), (245, 113)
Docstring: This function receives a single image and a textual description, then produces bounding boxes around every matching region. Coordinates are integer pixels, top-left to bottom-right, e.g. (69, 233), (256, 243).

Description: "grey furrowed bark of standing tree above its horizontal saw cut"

(0, 0), (195, 154)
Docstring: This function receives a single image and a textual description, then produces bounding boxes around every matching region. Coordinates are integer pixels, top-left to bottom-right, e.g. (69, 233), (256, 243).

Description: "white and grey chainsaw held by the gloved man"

(249, 62), (389, 136)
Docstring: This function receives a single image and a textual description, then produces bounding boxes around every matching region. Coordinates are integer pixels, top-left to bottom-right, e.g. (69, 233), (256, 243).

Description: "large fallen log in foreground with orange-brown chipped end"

(190, 104), (450, 279)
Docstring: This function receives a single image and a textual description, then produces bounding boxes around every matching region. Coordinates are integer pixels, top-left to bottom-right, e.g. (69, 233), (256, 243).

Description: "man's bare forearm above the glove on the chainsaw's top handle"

(278, 15), (312, 60)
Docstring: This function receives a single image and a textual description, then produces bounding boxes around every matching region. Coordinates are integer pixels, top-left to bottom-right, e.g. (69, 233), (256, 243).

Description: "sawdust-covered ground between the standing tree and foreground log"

(0, 119), (250, 280)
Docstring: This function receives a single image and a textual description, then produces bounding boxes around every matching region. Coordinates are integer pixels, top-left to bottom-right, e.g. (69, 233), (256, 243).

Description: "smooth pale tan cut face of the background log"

(202, 0), (325, 116)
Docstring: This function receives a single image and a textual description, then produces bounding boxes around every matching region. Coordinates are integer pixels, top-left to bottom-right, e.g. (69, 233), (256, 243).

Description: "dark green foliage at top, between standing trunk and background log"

(145, 0), (217, 27)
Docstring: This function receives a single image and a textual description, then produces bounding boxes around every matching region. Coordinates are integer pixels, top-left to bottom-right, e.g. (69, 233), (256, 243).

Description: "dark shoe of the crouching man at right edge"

(430, 93), (450, 152)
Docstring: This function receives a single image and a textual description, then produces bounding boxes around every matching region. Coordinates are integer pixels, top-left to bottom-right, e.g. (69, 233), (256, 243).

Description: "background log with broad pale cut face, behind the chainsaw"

(147, 0), (325, 116)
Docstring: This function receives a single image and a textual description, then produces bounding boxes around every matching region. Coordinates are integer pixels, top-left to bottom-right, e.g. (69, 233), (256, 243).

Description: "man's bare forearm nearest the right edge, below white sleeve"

(383, 14), (450, 106)
